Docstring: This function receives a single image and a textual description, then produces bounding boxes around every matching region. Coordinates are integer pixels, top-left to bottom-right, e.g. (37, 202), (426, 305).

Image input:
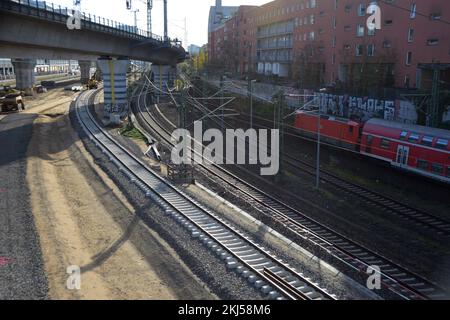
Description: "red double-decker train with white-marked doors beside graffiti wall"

(295, 111), (450, 184)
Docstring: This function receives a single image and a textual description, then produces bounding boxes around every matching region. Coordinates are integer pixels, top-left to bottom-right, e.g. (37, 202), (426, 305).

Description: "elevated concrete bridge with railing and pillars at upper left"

(0, 0), (186, 118)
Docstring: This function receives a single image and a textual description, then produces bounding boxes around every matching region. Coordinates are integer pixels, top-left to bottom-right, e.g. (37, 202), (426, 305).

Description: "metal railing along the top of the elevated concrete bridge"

(0, 0), (181, 47)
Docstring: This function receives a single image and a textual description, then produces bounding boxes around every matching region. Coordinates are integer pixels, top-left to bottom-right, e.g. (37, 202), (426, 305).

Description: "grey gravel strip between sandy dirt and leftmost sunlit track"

(70, 105), (263, 300)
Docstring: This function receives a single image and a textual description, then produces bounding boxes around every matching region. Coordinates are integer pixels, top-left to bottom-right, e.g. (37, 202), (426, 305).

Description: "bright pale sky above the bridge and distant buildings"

(51, 0), (270, 46)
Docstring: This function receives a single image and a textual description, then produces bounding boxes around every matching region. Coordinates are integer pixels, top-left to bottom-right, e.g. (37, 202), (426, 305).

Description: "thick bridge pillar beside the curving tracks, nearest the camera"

(98, 58), (130, 125)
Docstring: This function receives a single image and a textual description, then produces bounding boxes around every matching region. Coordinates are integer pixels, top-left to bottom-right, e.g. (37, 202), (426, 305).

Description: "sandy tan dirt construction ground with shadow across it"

(0, 90), (215, 299)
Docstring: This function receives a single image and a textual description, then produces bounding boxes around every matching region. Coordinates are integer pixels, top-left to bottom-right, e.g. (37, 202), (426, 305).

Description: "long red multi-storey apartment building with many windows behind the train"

(209, 0), (450, 88)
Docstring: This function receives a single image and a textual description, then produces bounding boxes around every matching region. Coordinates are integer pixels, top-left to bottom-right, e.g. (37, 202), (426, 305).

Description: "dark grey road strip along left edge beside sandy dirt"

(0, 113), (47, 300)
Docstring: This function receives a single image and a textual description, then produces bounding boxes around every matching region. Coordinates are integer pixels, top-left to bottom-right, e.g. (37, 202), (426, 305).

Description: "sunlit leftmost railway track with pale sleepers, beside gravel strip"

(75, 90), (335, 300)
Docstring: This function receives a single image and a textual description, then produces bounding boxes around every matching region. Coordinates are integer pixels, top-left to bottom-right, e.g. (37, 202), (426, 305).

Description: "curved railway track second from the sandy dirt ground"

(136, 80), (449, 300)
